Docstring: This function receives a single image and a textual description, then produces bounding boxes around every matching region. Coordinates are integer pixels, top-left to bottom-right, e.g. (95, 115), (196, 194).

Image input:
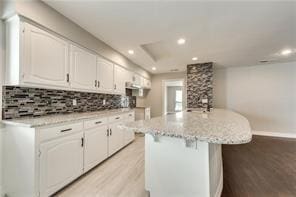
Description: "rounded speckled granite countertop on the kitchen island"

(122, 109), (252, 144)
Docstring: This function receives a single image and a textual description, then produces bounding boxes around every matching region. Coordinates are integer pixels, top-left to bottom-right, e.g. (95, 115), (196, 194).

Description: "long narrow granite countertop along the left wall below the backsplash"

(2, 108), (133, 127)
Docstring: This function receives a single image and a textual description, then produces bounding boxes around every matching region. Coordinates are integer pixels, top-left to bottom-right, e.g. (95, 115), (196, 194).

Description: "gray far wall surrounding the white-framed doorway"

(145, 72), (186, 117)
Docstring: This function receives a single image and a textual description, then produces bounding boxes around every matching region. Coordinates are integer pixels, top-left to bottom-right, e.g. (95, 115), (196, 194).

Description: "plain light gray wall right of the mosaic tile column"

(214, 62), (296, 134)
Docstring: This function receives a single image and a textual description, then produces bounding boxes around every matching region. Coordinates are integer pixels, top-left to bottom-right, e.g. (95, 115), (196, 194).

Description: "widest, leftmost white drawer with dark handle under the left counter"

(38, 122), (83, 142)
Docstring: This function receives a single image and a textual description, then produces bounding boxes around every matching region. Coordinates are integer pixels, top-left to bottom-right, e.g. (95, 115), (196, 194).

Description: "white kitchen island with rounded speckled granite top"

(123, 109), (252, 197)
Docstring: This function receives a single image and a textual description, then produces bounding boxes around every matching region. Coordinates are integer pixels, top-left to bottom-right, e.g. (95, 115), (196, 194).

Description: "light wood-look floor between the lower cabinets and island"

(55, 136), (148, 197)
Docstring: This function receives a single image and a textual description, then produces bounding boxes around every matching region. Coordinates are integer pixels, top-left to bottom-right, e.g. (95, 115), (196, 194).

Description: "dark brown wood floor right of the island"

(222, 136), (296, 197)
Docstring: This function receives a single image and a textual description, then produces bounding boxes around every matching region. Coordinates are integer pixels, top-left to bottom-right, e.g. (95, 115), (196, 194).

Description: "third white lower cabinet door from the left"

(108, 122), (124, 156)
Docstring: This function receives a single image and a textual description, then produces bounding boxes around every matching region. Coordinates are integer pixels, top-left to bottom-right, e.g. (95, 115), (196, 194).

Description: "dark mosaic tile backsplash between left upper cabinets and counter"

(2, 86), (136, 119)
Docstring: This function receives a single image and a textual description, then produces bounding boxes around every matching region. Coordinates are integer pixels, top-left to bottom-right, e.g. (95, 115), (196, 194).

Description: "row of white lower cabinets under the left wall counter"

(3, 112), (134, 197)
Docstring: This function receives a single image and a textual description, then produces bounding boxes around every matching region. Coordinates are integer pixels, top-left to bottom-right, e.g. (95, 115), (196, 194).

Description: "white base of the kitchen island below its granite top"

(145, 134), (223, 197)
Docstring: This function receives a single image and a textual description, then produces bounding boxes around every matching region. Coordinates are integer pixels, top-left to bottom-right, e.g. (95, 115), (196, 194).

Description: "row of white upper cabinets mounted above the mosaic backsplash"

(4, 15), (151, 94)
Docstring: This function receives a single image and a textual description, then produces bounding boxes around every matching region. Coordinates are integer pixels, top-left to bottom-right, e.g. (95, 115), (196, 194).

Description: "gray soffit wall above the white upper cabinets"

(2, 0), (150, 78)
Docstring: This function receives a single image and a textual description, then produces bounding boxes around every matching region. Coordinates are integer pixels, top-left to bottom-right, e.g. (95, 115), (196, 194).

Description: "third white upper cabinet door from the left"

(97, 58), (114, 92)
